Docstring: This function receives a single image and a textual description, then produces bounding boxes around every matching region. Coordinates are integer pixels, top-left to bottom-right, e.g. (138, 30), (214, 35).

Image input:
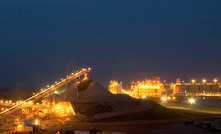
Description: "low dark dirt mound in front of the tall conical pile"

(84, 101), (175, 121)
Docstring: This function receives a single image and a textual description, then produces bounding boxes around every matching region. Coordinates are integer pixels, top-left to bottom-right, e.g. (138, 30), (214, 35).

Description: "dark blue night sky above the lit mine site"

(0, 0), (221, 86)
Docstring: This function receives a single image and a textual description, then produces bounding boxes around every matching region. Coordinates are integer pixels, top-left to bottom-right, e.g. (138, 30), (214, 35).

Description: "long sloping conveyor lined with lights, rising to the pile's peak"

(0, 68), (91, 118)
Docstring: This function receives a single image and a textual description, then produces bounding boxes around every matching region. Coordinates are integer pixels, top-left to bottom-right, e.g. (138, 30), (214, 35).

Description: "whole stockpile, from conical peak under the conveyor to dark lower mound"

(59, 79), (174, 121)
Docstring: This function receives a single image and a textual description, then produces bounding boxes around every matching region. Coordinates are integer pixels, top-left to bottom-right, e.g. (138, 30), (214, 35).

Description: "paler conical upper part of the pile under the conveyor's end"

(59, 79), (134, 103)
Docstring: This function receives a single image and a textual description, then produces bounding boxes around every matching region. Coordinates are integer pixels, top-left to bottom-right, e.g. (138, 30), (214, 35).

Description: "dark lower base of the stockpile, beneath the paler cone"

(72, 100), (175, 121)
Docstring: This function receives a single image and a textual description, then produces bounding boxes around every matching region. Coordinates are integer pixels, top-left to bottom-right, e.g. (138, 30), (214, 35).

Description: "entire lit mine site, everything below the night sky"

(0, 68), (221, 134)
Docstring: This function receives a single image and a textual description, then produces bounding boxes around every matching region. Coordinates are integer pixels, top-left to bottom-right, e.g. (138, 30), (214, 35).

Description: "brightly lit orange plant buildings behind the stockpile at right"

(108, 77), (221, 101)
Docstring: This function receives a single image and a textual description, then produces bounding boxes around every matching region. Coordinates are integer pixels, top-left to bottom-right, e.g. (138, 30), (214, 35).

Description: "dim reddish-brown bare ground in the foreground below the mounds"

(38, 110), (220, 134)
